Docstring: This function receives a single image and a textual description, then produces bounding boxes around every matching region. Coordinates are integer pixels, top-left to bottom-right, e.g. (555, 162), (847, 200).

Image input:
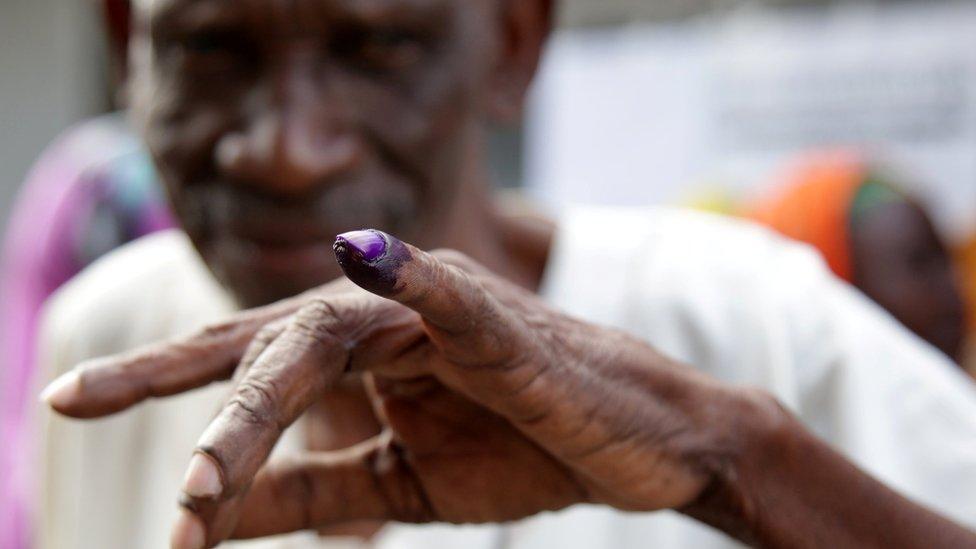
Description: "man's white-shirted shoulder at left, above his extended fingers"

(41, 230), (232, 370)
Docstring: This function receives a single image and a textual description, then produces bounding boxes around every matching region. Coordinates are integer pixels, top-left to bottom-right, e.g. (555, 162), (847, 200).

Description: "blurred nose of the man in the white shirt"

(216, 66), (362, 194)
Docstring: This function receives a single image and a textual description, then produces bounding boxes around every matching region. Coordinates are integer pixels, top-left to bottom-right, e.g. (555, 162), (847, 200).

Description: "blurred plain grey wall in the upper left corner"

(0, 0), (108, 242)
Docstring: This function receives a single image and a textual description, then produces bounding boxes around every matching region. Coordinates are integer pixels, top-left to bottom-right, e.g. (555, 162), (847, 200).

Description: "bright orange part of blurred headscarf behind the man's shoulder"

(745, 153), (867, 282)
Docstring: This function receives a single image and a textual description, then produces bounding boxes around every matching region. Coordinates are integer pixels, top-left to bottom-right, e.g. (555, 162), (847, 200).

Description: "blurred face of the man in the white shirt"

(132, 0), (502, 306)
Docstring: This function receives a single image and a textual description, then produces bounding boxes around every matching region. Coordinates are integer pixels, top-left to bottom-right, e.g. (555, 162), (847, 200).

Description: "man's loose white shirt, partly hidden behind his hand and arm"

(36, 209), (976, 549)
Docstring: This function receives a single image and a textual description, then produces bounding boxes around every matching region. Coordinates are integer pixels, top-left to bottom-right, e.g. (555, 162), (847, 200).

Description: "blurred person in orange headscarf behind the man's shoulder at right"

(745, 152), (966, 363)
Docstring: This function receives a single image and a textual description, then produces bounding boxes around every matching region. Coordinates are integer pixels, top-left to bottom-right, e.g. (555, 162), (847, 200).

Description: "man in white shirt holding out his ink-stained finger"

(34, 0), (976, 548)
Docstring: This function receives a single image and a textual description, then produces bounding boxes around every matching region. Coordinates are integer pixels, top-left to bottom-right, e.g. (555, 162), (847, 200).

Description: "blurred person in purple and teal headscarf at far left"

(0, 0), (174, 548)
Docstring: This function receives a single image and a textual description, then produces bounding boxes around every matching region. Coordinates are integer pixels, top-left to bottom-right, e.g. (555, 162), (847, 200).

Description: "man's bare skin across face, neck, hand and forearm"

(45, 0), (976, 549)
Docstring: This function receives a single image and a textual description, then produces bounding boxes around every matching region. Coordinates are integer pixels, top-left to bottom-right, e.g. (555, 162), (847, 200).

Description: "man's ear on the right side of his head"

(490, 0), (555, 123)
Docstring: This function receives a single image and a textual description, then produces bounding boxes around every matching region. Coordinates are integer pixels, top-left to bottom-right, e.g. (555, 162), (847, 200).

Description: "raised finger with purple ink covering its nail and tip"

(335, 231), (558, 423)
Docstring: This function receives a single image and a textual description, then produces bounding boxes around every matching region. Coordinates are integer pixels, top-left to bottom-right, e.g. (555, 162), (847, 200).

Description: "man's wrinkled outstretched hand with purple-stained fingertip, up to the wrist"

(45, 232), (748, 547)
